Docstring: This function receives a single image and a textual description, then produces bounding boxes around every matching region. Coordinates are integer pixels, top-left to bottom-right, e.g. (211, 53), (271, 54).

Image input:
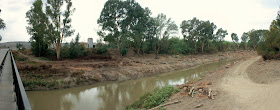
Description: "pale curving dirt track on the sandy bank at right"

(221, 57), (280, 110)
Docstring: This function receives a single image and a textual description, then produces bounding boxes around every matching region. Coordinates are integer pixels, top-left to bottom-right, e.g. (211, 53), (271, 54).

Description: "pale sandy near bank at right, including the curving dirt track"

(165, 57), (280, 110)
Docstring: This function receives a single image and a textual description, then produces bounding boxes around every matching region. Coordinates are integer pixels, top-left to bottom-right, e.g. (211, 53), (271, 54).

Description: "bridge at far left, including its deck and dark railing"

(0, 49), (31, 110)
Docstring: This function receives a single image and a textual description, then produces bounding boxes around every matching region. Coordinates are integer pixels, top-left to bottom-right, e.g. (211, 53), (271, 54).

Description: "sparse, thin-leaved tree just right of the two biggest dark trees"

(154, 13), (178, 58)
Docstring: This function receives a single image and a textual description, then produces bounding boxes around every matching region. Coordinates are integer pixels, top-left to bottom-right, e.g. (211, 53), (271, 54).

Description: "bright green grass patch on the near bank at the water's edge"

(126, 86), (179, 110)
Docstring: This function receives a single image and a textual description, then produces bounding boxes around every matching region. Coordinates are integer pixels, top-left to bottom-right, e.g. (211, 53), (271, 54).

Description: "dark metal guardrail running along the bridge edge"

(10, 52), (31, 110)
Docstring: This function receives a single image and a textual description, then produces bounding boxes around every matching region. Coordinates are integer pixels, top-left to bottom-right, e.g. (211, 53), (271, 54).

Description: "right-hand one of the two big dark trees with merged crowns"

(122, 0), (150, 54)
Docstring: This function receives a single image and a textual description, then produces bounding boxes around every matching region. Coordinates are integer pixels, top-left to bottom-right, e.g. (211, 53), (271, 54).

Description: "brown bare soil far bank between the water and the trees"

(14, 51), (256, 90)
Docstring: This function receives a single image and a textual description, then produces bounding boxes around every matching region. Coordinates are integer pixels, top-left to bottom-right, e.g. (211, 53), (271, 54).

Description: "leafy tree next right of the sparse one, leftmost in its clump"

(180, 17), (201, 53)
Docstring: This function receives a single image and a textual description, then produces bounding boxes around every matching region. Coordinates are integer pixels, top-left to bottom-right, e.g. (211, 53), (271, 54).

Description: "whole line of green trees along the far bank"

(26, 0), (274, 59)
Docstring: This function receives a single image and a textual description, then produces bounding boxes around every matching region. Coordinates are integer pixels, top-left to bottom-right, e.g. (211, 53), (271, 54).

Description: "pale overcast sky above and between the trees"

(0, 0), (280, 42)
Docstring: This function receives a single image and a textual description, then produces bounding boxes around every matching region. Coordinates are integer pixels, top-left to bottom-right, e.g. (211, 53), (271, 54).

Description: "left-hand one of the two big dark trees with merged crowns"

(97, 0), (127, 55)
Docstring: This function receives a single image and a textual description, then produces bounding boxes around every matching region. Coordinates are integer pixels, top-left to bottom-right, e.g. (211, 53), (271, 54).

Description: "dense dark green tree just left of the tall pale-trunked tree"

(26, 0), (48, 57)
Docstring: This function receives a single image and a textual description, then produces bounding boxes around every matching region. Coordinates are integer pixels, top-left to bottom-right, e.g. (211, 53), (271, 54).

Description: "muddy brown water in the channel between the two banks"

(27, 60), (235, 110)
